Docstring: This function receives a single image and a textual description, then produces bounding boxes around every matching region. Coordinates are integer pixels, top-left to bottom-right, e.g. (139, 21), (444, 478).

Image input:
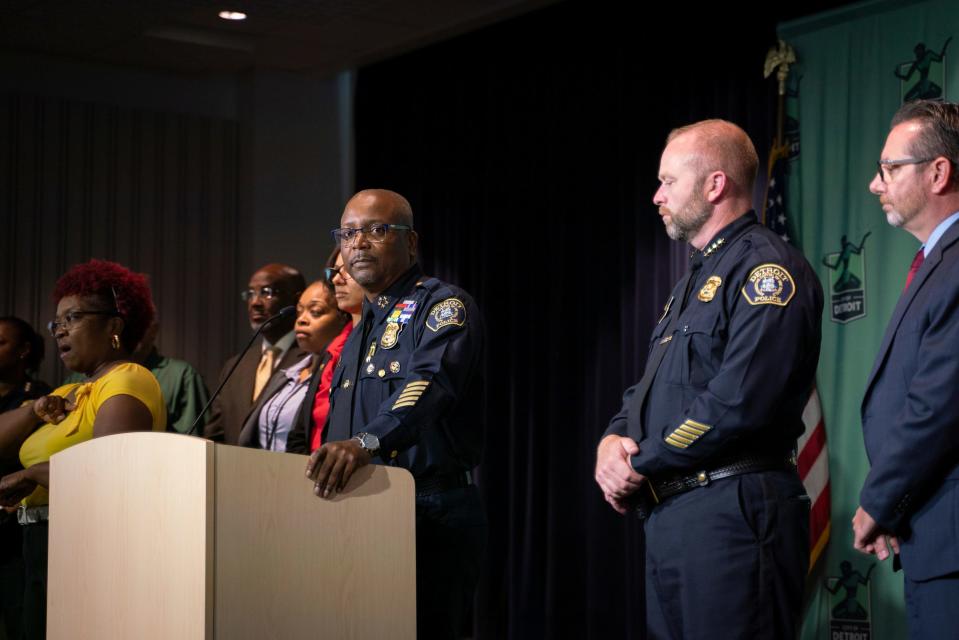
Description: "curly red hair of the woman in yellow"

(53, 260), (156, 351)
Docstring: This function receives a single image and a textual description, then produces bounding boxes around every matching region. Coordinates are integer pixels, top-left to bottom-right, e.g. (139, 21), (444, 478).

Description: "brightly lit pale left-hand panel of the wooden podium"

(47, 433), (214, 640)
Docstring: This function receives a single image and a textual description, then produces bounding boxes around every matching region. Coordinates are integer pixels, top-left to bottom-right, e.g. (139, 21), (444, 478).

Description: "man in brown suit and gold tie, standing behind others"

(203, 264), (307, 444)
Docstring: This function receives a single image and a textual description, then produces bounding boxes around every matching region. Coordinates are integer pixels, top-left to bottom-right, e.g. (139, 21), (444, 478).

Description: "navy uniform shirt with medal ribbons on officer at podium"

(324, 265), (485, 478)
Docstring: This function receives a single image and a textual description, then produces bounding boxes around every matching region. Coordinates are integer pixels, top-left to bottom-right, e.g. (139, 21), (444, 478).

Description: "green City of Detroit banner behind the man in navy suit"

(779, 0), (959, 640)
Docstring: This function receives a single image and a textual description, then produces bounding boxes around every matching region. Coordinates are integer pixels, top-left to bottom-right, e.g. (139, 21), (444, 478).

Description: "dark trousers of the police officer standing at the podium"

(416, 486), (487, 640)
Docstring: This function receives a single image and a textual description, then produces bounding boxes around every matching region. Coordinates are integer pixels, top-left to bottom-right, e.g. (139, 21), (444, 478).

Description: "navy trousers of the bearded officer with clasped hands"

(645, 471), (809, 640)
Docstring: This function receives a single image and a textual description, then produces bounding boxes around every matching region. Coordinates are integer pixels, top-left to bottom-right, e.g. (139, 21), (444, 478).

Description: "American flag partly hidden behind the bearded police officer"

(762, 138), (831, 572)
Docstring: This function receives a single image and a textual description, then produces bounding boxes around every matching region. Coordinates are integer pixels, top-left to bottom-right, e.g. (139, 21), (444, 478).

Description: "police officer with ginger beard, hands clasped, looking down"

(596, 120), (823, 640)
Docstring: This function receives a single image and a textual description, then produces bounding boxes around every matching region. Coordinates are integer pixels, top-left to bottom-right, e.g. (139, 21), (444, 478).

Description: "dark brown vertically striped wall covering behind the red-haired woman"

(0, 93), (240, 386)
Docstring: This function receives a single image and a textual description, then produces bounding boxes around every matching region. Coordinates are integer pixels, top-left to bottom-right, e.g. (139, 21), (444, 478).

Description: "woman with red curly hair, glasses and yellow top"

(0, 260), (166, 638)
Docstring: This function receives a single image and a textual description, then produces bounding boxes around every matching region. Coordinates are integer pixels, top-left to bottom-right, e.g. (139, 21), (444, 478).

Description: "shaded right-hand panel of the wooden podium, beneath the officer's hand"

(214, 446), (416, 640)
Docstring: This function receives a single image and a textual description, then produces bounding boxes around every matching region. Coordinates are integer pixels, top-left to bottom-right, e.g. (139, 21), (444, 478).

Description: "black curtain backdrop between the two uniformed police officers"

(355, 2), (792, 639)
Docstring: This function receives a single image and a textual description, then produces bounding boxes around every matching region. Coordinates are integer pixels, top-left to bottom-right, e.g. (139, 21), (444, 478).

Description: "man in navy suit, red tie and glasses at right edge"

(853, 101), (959, 638)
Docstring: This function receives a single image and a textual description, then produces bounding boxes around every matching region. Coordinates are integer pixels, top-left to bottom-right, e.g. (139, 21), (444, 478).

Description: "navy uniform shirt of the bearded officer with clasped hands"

(606, 212), (823, 478)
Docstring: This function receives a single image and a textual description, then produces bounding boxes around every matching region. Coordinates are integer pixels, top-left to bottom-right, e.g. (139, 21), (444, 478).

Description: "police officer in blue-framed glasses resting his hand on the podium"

(307, 189), (486, 639)
